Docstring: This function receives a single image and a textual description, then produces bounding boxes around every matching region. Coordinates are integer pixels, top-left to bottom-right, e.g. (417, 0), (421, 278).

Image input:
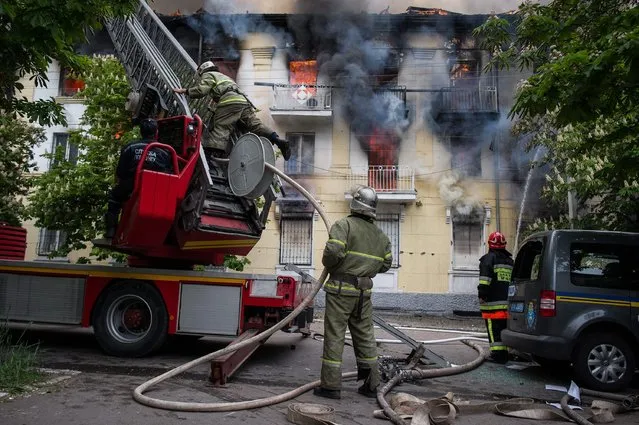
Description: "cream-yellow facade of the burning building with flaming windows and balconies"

(23, 4), (523, 313)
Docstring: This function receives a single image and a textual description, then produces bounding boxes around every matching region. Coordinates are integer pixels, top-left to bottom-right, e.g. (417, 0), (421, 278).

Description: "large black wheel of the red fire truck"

(93, 282), (168, 357)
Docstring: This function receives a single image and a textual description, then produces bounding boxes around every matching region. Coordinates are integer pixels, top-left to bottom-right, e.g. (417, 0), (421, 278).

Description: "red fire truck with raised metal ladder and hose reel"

(0, 0), (313, 383)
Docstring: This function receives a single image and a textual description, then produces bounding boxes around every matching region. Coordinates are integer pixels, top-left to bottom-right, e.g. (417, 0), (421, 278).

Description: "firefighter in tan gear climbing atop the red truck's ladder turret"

(173, 61), (291, 161)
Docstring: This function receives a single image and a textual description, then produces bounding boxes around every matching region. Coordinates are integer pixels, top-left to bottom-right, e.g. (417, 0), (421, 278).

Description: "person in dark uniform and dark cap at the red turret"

(104, 119), (172, 239)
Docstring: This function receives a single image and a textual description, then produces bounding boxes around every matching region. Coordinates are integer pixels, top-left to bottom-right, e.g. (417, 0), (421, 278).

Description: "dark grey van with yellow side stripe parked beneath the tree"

(502, 230), (639, 391)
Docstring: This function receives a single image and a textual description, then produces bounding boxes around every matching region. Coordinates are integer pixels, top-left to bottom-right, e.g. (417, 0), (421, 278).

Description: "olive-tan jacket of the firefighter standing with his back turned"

(322, 214), (393, 297)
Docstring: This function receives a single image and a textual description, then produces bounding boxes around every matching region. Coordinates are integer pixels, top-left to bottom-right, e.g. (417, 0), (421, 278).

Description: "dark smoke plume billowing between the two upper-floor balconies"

(289, 0), (409, 138)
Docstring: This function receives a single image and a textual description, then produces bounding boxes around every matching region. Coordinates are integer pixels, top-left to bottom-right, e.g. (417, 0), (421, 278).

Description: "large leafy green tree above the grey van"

(475, 0), (639, 231)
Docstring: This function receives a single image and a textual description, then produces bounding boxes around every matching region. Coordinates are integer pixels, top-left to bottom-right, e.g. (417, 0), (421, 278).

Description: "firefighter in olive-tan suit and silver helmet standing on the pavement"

(314, 187), (393, 399)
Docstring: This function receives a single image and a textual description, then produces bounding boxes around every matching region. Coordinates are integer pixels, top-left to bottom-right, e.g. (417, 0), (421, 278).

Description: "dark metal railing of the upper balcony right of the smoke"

(433, 87), (499, 116)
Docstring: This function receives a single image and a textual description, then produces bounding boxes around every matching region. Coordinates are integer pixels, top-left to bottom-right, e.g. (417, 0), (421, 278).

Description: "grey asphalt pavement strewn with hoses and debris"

(0, 316), (639, 425)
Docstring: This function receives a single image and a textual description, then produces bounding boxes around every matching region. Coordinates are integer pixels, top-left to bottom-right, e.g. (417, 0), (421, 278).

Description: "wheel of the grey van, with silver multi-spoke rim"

(574, 332), (636, 391)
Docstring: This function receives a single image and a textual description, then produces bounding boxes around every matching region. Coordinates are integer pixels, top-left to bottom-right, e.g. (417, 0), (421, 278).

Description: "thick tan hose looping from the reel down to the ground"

(133, 163), (336, 412)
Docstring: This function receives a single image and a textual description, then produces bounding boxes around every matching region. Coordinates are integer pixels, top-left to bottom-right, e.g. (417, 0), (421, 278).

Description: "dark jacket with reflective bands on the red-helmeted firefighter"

(477, 249), (514, 319)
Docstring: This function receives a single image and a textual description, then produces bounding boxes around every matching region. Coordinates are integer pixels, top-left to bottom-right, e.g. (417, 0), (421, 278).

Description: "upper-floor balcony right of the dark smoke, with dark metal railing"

(432, 87), (499, 122)
